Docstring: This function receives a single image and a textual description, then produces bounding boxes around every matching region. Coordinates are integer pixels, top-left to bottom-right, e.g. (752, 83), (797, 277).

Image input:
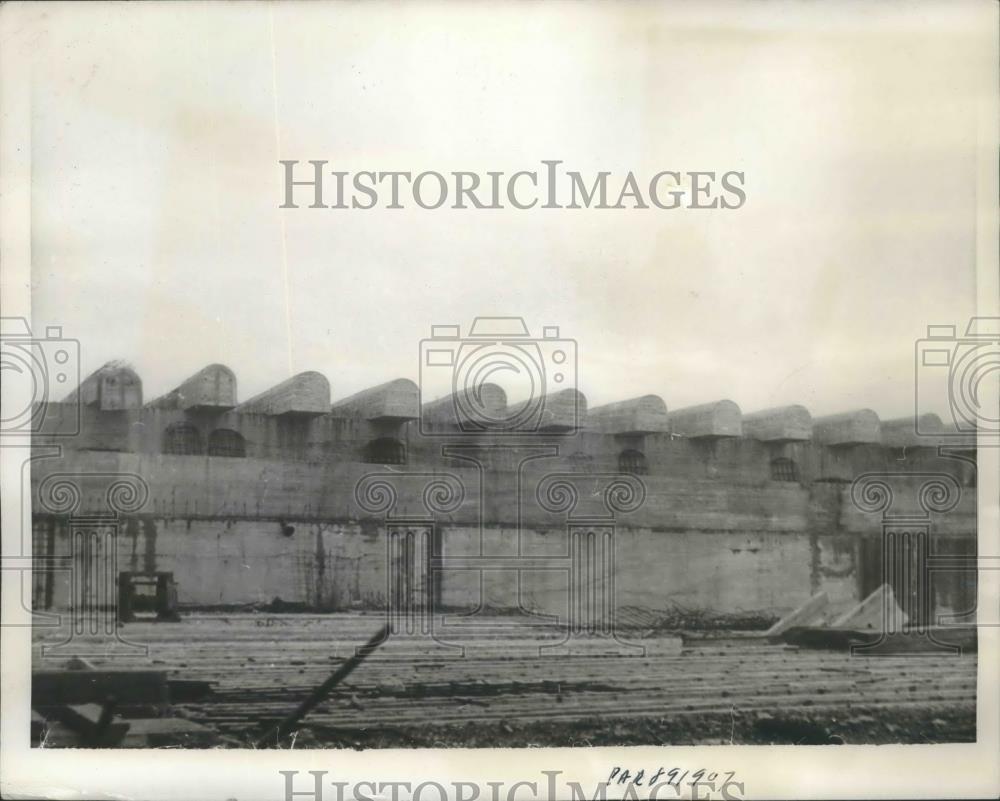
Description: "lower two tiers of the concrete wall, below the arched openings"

(32, 451), (976, 616)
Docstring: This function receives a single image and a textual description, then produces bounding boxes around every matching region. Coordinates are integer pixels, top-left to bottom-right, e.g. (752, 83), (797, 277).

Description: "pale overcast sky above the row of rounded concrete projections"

(23, 3), (995, 417)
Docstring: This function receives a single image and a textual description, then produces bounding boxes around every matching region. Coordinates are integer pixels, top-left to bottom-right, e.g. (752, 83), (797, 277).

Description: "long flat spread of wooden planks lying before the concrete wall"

(35, 614), (977, 743)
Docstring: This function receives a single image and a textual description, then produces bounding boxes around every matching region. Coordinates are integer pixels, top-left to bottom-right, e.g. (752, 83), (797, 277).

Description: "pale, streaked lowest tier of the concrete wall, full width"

(34, 506), (974, 618)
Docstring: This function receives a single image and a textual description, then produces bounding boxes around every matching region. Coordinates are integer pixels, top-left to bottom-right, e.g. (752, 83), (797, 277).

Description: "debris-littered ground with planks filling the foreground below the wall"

(33, 613), (977, 748)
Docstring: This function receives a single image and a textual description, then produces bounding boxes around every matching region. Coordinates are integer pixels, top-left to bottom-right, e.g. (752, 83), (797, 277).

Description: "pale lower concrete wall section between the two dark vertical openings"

(442, 528), (858, 619)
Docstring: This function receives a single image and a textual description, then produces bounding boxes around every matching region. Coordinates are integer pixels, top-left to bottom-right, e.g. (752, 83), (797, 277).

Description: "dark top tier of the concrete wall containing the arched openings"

(34, 400), (976, 486)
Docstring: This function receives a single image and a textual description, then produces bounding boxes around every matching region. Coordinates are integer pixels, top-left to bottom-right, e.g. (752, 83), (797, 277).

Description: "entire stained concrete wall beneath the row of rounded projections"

(31, 396), (976, 615)
